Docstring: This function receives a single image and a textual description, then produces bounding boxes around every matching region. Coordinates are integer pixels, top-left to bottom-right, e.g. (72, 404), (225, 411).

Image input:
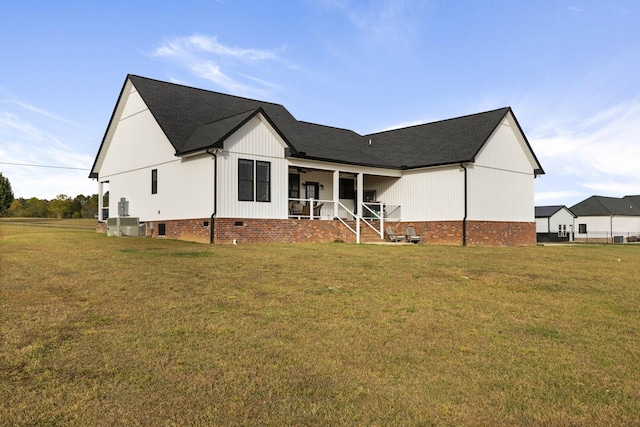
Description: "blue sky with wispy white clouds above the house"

(0, 0), (640, 206)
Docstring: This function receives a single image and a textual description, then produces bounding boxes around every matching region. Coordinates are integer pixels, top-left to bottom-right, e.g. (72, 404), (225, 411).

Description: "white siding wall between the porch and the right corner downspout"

(398, 166), (464, 221)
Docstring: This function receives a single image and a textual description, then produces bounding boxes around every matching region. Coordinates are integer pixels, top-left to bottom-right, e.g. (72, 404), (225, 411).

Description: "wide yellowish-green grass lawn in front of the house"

(0, 221), (640, 426)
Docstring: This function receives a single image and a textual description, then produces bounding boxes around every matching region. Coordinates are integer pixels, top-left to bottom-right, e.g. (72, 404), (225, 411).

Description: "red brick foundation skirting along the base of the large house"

(96, 218), (536, 246)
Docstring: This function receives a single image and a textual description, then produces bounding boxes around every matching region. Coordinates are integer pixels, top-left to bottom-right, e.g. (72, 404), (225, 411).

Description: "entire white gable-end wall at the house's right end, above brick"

(467, 114), (538, 222)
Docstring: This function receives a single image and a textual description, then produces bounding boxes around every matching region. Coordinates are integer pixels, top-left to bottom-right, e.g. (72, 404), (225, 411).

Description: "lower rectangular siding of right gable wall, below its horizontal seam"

(467, 165), (535, 222)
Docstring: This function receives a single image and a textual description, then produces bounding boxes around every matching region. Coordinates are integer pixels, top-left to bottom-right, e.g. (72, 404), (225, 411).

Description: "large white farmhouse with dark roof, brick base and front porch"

(90, 75), (544, 245)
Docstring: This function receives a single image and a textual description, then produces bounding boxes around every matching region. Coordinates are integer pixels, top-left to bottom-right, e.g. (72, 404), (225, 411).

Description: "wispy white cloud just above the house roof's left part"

(152, 34), (280, 97)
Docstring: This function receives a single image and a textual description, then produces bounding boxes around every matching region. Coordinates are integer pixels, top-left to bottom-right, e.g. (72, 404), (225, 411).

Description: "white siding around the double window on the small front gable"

(216, 114), (289, 219)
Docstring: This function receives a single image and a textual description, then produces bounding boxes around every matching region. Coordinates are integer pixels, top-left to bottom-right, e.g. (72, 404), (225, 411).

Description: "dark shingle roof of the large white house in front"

(104, 75), (544, 174)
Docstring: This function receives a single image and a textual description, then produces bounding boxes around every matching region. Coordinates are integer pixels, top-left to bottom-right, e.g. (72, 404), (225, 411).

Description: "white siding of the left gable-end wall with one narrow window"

(99, 85), (214, 221)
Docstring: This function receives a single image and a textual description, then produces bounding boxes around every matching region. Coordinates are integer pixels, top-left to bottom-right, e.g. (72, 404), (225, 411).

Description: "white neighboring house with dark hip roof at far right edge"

(571, 196), (640, 243)
